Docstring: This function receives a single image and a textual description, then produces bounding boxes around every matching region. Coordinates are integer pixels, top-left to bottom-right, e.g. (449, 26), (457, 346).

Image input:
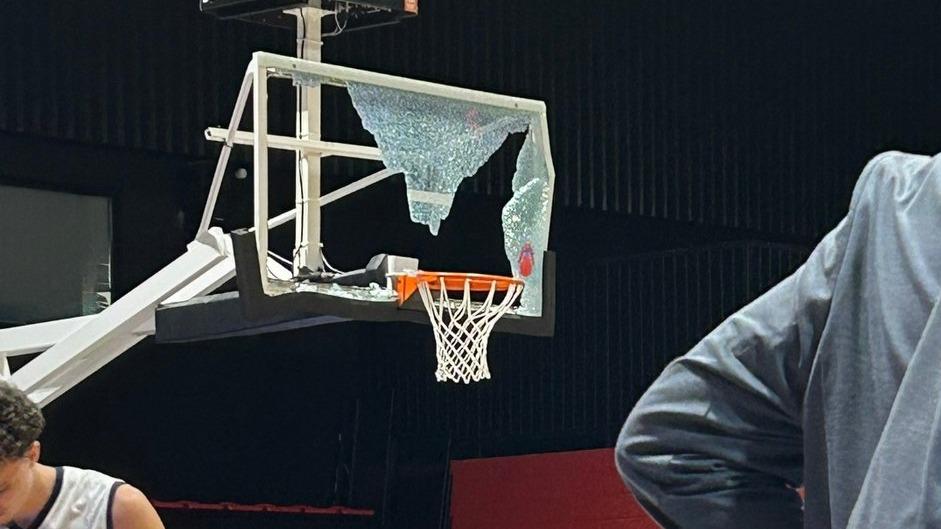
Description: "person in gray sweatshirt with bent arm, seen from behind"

(615, 152), (941, 529)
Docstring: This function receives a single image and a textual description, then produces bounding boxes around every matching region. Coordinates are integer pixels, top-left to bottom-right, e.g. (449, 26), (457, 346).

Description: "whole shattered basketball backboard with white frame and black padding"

(151, 52), (555, 380)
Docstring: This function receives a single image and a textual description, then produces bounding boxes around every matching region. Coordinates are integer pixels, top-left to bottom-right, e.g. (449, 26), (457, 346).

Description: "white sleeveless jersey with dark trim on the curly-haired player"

(10, 467), (123, 529)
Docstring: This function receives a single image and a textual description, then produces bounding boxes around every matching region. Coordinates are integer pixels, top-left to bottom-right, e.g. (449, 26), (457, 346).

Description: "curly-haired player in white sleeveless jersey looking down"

(0, 381), (164, 529)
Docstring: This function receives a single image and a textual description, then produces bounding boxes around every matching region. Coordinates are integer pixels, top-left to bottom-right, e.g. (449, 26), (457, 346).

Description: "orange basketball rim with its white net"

(397, 272), (523, 384)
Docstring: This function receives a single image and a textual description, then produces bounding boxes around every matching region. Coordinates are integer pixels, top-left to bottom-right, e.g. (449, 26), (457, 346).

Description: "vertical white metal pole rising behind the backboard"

(293, 7), (327, 275)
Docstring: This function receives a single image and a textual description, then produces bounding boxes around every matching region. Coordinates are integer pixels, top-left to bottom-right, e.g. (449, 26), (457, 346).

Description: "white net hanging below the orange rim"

(418, 277), (523, 384)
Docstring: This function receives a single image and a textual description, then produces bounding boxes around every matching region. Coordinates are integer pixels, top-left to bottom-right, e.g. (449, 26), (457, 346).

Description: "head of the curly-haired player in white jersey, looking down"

(0, 380), (46, 525)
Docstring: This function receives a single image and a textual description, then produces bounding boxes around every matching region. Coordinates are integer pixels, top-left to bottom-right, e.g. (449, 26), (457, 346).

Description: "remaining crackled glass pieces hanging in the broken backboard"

(330, 82), (551, 316)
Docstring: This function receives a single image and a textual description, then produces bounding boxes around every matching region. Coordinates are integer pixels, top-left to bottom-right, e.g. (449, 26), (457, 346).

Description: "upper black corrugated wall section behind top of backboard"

(0, 0), (941, 237)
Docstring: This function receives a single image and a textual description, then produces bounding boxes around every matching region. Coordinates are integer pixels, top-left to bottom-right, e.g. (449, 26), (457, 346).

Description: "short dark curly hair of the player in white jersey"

(0, 380), (46, 462)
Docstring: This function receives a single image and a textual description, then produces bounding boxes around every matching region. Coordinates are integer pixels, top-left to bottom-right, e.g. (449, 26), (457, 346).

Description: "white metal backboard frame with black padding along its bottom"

(197, 52), (555, 335)
